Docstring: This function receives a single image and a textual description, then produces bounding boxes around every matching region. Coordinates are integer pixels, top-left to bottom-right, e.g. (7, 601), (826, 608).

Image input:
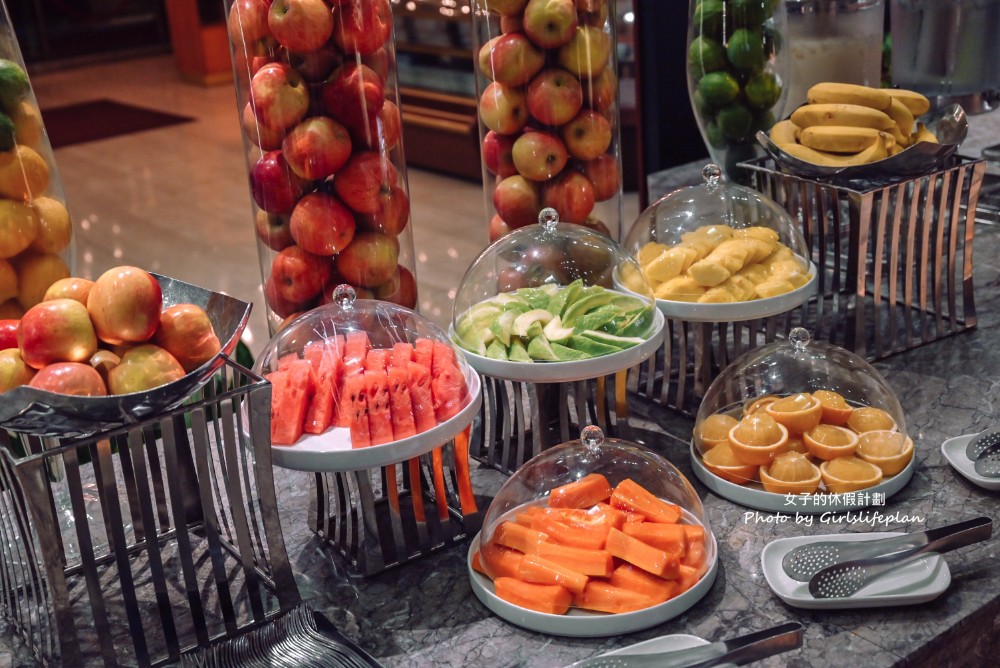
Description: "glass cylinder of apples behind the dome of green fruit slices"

(472, 0), (622, 241)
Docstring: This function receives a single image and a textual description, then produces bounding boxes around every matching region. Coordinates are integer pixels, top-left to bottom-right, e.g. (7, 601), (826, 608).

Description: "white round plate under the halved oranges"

(691, 442), (917, 515)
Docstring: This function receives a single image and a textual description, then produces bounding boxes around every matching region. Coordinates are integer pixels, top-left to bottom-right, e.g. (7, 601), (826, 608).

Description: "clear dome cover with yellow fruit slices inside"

(622, 164), (810, 303)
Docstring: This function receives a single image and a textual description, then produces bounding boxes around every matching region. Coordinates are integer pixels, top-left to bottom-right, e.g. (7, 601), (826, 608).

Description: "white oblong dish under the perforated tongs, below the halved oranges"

(760, 531), (951, 610)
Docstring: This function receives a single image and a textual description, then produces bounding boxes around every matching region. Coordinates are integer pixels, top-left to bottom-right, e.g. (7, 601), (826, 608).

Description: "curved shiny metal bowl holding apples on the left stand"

(0, 274), (252, 438)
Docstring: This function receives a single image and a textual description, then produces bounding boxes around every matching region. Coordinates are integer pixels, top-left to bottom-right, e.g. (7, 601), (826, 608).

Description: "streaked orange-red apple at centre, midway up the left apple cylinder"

(281, 116), (351, 181)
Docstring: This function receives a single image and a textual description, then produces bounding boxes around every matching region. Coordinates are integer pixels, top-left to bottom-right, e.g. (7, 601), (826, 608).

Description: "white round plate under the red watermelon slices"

(271, 368), (482, 472)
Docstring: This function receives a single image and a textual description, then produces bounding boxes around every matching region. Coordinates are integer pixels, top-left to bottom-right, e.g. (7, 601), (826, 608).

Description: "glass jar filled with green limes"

(687, 0), (786, 181)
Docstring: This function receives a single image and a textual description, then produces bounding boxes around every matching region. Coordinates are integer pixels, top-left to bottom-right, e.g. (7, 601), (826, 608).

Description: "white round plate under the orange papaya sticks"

(466, 511), (719, 636)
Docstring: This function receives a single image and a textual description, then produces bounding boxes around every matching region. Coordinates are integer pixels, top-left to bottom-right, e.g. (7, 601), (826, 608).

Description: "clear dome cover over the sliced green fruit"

(452, 209), (655, 361)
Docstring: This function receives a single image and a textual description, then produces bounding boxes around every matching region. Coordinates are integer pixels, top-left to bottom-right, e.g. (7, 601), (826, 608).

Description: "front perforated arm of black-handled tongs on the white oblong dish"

(809, 517), (993, 598)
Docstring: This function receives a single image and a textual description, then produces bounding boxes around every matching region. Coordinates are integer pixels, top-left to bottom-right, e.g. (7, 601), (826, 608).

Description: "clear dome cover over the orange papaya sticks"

(481, 426), (715, 578)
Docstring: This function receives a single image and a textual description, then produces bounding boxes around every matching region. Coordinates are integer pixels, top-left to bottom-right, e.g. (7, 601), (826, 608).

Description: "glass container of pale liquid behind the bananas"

(785, 0), (885, 109)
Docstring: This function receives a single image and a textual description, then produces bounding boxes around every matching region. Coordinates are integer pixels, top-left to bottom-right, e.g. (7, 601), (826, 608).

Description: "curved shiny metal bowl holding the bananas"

(757, 104), (969, 180)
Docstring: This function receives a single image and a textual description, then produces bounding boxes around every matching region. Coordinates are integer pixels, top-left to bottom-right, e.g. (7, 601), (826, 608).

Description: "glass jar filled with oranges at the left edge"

(0, 2), (73, 320)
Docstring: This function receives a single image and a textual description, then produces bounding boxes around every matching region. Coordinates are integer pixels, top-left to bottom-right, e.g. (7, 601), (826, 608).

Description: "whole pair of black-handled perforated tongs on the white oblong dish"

(800, 517), (993, 598)
